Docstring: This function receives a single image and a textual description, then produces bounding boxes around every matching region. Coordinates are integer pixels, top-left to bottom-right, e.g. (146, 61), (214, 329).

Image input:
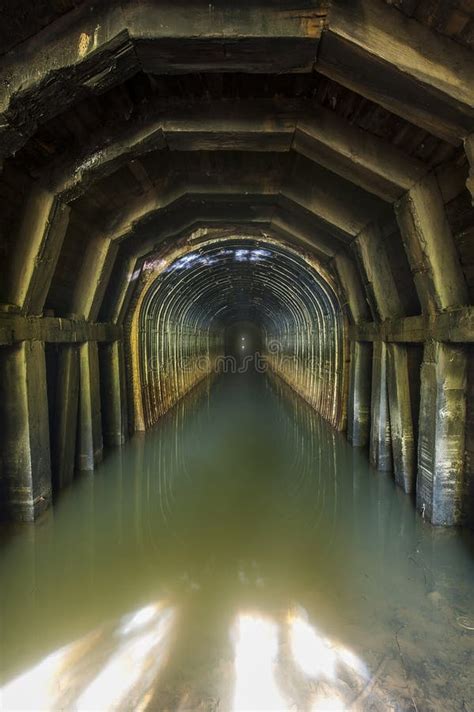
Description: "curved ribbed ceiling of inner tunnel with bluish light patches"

(137, 239), (340, 327)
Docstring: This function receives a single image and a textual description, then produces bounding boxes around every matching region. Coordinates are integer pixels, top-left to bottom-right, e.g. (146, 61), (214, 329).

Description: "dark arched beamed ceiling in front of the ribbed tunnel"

(0, 0), (474, 326)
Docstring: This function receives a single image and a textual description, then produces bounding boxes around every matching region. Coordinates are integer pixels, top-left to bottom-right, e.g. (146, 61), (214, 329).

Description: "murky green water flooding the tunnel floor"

(0, 375), (474, 711)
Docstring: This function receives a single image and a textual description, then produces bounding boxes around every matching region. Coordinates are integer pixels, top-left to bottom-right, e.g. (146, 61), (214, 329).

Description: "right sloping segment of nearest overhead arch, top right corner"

(317, 0), (474, 145)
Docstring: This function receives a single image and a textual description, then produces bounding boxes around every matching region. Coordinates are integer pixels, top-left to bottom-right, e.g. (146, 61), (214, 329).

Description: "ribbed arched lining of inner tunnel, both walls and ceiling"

(129, 235), (347, 430)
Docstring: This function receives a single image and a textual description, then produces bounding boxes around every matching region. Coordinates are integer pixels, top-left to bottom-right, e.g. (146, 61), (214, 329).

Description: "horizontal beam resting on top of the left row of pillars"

(0, 312), (122, 347)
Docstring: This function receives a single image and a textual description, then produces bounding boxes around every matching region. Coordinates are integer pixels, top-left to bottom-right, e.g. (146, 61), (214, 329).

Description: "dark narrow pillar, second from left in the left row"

(51, 344), (79, 489)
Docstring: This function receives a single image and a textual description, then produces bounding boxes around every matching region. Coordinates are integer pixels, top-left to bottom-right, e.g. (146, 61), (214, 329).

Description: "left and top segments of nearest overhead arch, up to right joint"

(0, 0), (327, 159)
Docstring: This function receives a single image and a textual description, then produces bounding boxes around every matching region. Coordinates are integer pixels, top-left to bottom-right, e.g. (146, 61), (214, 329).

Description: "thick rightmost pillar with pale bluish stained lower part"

(416, 341), (467, 525)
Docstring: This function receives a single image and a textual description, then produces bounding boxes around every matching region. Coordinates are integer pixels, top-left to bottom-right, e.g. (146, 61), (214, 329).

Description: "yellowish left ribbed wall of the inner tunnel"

(126, 251), (224, 430)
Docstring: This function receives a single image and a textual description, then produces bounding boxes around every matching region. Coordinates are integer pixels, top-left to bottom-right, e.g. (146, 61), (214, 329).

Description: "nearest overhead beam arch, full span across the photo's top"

(0, 0), (474, 164)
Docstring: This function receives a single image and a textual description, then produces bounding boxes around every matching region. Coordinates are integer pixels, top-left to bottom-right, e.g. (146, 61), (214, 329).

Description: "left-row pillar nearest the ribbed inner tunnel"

(99, 341), (128, 447)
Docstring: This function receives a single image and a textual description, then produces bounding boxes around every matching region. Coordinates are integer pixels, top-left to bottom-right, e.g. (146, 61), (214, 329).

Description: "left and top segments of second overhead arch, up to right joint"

(48, 99), (298, 202)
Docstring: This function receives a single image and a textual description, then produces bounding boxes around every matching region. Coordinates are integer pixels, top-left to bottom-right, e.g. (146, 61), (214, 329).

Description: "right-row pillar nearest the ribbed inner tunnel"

(347, 341), (372, 447)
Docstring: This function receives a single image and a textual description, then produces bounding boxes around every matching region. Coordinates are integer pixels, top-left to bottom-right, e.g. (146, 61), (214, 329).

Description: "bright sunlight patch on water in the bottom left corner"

(0, 603), (176, 712)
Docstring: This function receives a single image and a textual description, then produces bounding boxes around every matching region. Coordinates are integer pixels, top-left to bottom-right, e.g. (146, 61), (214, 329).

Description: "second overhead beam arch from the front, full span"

(41, 98), (426, 203)
